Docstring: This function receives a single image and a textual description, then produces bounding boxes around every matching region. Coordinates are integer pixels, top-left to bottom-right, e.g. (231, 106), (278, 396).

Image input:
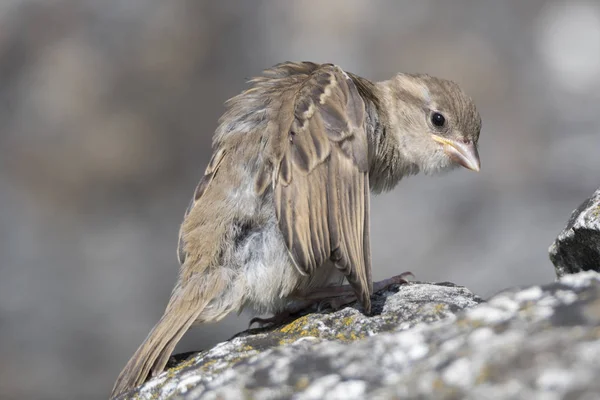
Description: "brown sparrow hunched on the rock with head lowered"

(111, 61), (481, 397)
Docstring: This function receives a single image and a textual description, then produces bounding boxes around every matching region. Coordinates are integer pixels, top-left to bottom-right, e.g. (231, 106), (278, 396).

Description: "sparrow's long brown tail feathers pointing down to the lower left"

(111, 278), (220, 398)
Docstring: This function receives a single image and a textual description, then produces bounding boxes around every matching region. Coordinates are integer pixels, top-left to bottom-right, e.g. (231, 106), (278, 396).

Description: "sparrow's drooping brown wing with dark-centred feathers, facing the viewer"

(272, 65), (372, 310)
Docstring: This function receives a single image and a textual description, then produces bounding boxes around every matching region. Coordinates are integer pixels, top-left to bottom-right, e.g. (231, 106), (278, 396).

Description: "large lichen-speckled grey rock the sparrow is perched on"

(116, 271), (600, 400)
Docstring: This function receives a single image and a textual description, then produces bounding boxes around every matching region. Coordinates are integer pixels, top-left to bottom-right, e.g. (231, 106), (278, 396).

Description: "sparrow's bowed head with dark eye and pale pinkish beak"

(383, 74), (481, 174)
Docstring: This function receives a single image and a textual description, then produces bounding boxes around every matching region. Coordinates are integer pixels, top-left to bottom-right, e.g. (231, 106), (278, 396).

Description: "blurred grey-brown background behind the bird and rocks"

(0, 0), (600, 399)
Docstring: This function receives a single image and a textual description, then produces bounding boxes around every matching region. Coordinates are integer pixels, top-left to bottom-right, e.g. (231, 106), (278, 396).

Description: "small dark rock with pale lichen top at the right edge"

(549, 189), (600, 277)
